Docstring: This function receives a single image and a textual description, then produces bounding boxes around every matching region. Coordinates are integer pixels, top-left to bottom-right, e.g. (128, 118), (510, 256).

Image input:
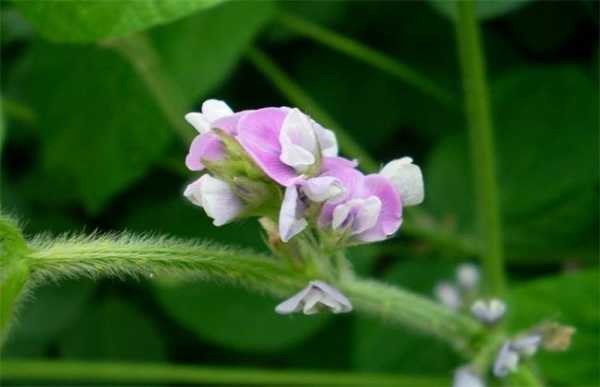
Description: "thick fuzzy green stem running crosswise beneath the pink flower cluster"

(5, 226), (479, 344)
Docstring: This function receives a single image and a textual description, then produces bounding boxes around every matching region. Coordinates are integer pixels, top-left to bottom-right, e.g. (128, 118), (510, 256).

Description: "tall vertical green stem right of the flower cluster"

(456, 0), (504, 295)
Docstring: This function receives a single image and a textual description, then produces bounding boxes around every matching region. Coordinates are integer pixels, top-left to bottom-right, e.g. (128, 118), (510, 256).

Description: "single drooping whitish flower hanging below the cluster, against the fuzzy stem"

(275, 280), (352, 315)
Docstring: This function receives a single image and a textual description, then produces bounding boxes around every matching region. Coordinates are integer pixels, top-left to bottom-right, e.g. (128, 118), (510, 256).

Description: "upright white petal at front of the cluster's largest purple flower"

(279, 109), (318, 173)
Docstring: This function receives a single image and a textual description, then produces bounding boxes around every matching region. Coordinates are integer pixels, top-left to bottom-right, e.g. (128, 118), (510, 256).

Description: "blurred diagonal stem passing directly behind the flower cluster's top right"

(247, 48), (379, 171)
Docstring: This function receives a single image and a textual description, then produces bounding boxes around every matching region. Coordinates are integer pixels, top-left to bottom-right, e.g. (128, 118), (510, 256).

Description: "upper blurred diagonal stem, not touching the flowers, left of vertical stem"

(275, 11), (455, 107)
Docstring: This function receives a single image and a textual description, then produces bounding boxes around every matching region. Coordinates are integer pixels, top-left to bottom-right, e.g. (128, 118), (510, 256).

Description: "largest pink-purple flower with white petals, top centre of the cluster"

(236, 107), (338, 186)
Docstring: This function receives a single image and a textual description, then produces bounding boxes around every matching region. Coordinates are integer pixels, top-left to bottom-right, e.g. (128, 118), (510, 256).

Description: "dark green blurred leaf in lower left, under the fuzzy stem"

(2, 280), (95, 357)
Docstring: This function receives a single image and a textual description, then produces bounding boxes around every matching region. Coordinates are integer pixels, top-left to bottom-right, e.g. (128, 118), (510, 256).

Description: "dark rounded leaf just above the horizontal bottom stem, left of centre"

(59, 297), (166, 360)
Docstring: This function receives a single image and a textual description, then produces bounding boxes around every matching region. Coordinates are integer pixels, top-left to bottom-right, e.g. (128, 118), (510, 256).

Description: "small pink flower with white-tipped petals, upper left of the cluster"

(185, 99), (248, 171)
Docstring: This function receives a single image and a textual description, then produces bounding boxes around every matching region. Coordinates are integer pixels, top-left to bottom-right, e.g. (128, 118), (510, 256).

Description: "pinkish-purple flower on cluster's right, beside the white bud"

(319, 165), (402, 243)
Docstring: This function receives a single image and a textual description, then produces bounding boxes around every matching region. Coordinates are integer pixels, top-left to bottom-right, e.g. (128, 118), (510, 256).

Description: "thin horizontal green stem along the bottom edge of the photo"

(2, 360), (448, 387)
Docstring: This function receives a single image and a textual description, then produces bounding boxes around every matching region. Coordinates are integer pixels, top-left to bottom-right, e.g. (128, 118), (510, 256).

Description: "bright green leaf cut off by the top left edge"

(16, 0), (221, 43)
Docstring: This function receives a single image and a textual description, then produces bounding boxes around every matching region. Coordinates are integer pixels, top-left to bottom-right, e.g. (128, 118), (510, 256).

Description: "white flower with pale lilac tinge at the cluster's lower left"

(183, 174), (244, 226)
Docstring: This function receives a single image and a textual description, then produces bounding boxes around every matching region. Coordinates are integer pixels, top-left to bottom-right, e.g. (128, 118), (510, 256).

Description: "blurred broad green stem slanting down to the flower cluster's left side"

(102, 34), (194, 147)
